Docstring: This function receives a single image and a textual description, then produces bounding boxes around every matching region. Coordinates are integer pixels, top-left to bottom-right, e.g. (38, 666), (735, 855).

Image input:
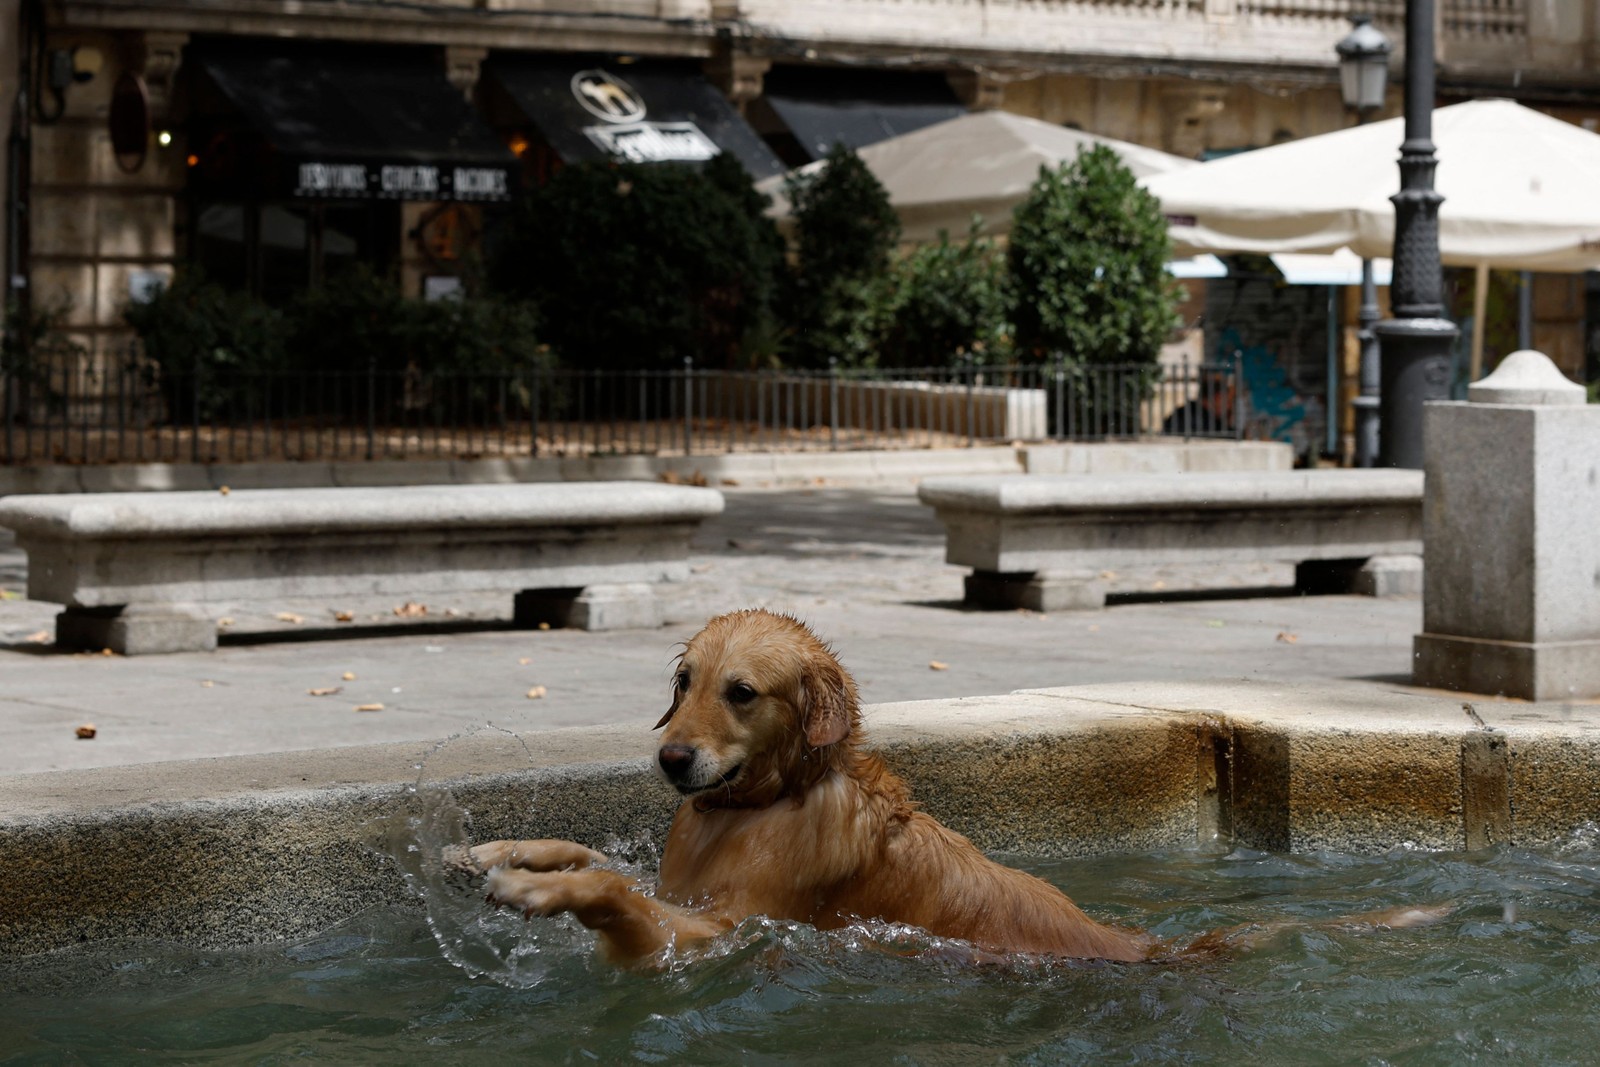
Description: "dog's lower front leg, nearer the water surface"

(488, 867), (728, 966)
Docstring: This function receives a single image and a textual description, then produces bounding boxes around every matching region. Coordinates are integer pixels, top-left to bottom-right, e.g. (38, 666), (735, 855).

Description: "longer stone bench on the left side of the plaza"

(0, 482), (723, 656)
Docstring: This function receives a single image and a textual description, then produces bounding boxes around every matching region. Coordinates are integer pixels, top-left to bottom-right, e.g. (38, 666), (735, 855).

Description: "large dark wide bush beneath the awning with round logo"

(488, 157), (782, 368)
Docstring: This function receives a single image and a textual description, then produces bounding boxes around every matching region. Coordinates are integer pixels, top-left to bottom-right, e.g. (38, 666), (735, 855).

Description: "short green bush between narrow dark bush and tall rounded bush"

(877, 224), (1011, 366)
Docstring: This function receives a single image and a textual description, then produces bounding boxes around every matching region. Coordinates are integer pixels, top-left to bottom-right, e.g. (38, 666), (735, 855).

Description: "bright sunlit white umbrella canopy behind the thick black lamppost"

(1144, 101), (1600, 272)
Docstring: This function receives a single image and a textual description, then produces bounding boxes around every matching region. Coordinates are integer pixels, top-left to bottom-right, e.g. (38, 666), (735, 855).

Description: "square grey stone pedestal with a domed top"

(1413, 352), (1600, 701)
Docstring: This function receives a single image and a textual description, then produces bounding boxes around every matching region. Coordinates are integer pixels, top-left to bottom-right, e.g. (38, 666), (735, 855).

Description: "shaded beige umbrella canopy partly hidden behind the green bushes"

(757, 110), (1198, 243)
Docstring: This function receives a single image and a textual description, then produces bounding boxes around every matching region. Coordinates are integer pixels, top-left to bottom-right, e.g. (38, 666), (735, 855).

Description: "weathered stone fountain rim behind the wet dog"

(0, 680), (1600, 955)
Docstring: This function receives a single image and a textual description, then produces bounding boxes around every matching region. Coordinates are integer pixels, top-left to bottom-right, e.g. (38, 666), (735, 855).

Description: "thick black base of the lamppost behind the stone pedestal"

(1374, 318), (1461, 470)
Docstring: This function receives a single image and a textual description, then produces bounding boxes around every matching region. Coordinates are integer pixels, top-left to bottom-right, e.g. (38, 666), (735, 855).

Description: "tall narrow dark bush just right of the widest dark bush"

(786, 144), (899, 366)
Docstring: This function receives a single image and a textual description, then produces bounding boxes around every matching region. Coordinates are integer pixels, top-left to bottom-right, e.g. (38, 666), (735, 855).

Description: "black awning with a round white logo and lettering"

(483, 53), (784, 179)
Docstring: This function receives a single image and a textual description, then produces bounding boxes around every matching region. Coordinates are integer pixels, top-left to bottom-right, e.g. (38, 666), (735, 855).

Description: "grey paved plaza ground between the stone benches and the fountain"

(0, 485), (1421, 774)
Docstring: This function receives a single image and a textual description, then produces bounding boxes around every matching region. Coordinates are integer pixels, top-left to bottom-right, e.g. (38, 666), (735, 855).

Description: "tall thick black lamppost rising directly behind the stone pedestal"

(1376, 0), (1459, 469)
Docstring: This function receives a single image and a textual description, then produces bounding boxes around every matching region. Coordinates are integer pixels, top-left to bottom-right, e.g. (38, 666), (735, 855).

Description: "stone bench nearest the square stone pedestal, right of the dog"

(918, 469), (1422, 611)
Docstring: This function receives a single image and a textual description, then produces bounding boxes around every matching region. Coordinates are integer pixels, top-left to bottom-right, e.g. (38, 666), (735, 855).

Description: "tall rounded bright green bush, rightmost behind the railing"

(1008, 146), (1179, 363)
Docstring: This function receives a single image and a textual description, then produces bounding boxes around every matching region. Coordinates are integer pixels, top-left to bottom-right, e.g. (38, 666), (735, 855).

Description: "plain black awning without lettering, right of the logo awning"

(763, 67), (966, 160)
